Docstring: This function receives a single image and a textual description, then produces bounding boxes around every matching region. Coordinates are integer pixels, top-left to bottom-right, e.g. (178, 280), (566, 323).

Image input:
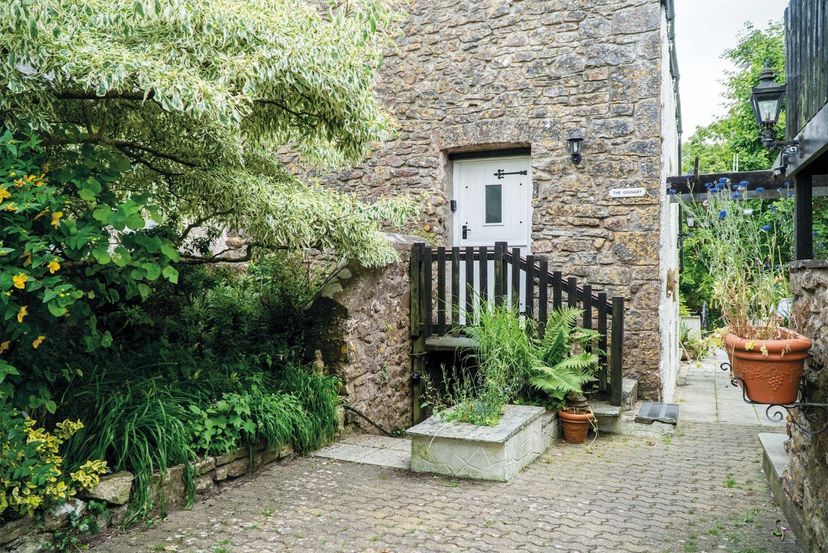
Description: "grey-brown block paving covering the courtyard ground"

(93, 423), (798, 553)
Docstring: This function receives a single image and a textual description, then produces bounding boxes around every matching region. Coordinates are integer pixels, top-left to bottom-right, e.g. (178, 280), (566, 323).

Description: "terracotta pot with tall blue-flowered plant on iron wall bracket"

(684, 179), (811, 404)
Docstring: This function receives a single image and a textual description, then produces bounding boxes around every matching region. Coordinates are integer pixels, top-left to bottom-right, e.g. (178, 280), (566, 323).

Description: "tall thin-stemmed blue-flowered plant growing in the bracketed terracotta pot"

(682, 178), (789, 340)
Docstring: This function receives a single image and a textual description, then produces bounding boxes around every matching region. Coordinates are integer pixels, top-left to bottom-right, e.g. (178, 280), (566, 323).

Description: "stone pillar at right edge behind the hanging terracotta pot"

(783, 261), (828, 552)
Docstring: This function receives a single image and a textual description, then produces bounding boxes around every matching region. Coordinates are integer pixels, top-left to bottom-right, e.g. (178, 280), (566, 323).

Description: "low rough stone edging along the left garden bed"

(0, 445), (293, 553)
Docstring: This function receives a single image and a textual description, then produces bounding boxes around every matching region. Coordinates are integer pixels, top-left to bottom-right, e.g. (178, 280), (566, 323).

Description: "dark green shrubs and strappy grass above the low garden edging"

(46, 254), (339, 520)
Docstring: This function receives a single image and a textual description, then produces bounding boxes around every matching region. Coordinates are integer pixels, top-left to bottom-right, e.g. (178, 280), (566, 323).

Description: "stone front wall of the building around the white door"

(324, 0), (677, 397)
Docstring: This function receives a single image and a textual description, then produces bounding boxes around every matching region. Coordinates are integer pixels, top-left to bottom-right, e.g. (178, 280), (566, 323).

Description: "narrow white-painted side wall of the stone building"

(658, 4), (681, 402)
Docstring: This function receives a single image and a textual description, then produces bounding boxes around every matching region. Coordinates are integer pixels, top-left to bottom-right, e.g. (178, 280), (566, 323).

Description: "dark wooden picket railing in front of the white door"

(410, 242), (624, 419)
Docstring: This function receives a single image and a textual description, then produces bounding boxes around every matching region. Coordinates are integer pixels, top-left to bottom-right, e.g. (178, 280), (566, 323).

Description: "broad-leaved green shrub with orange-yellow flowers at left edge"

(0, 132), (178, 413)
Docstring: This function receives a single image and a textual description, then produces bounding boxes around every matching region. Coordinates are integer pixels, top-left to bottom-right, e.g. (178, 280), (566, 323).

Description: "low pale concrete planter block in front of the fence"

(408, 405), (555, 482)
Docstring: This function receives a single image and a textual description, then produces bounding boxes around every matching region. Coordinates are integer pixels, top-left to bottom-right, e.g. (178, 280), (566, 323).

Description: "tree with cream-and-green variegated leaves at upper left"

(0, 0), (410, 265)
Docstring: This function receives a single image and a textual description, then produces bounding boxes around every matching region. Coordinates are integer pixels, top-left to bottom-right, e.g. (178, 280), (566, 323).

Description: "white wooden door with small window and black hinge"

(453, 156), (532, 324)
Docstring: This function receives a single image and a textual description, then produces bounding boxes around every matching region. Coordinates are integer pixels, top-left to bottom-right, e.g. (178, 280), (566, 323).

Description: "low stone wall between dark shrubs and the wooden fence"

(306, 234), (422, 433)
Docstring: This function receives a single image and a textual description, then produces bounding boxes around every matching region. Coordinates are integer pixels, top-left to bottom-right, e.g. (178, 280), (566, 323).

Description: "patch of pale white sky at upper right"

(675, 0), (788, 139)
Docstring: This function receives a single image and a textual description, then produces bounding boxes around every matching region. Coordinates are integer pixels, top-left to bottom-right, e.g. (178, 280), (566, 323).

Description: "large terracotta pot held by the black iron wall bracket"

(725, 330), (811, 404)
